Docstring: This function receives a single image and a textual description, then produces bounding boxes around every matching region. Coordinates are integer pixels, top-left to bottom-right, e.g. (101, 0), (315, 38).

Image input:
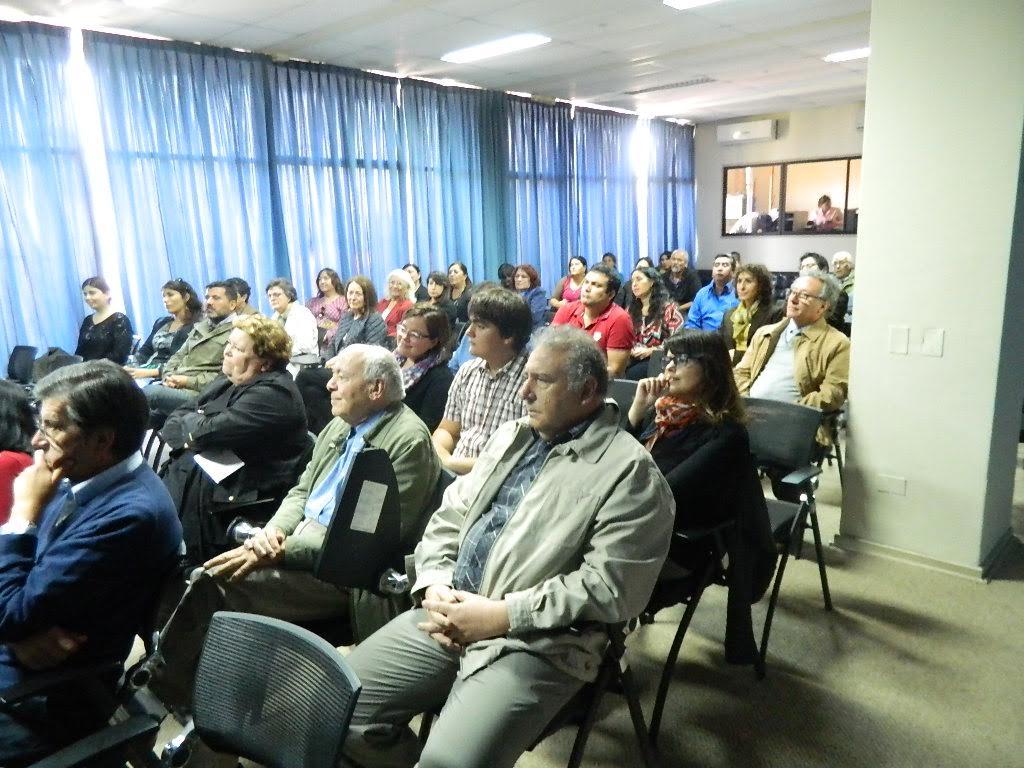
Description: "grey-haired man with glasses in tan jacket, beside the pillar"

(734, 269), (850, 421)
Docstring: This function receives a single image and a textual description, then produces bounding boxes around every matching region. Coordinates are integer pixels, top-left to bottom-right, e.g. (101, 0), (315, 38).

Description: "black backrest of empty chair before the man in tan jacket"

(743, 397), (821, 469)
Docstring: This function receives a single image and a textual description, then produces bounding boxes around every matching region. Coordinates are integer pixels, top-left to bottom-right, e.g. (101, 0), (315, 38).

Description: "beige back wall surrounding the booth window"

(694, 103), (863, 271)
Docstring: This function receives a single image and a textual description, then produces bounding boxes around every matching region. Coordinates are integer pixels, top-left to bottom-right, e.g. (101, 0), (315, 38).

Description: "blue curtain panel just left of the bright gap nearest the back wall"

(572, 109), (639, 264)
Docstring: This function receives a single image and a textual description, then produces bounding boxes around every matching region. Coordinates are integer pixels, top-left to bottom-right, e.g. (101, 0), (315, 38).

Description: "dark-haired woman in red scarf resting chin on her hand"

(629, 330), (752, 529)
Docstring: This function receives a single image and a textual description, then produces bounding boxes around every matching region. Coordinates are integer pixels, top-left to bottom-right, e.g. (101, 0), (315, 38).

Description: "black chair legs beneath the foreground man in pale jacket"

(420, 622), (658, 768)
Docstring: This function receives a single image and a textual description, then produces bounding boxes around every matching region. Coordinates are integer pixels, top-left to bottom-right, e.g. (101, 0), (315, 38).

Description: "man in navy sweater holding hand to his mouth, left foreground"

(0, 360), (181, 766)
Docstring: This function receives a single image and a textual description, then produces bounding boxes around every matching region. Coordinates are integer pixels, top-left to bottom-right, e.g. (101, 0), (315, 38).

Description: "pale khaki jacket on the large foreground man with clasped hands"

(413, 404), (676, 680)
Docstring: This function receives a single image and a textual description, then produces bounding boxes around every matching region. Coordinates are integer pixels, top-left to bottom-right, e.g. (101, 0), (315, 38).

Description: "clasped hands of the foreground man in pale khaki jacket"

(417, 585), (509, 652)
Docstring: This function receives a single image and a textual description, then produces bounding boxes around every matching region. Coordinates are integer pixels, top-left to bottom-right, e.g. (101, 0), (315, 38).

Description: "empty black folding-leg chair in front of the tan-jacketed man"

(744, 397), (833, 664)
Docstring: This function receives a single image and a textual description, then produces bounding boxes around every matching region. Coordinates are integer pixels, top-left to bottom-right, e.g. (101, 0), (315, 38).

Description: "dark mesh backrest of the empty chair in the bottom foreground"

(193, 611), (360, 768)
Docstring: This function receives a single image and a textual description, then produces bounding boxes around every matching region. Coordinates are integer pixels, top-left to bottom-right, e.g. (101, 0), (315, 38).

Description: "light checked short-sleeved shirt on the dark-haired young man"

(442, 350), (526, 459)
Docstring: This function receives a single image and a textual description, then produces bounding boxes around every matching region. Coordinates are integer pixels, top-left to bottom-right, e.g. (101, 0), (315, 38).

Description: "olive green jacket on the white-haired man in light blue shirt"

(267, 402), (440, 641)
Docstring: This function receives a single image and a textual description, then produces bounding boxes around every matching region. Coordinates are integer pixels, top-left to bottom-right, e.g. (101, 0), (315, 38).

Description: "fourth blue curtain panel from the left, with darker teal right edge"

(401, 83), (511, 281)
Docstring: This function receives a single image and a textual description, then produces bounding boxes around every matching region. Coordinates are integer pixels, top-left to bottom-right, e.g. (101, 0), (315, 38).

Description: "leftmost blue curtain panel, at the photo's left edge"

(0, 24), (98, 364)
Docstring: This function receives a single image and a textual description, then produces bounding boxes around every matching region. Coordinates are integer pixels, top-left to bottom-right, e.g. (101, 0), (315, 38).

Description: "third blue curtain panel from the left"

(270, 65), (409, 295)
